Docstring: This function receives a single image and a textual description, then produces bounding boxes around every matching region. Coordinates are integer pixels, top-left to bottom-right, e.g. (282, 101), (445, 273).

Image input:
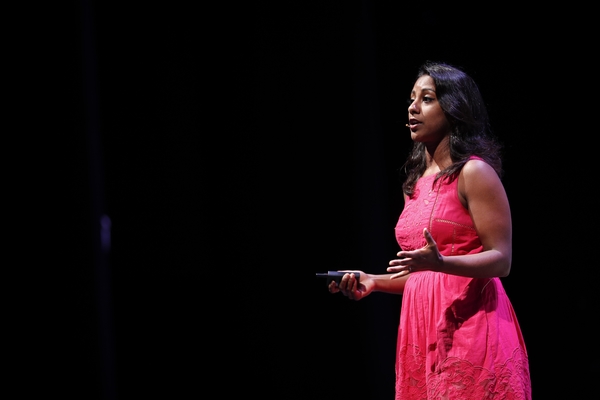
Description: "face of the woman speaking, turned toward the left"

(408, 75), (450, 143)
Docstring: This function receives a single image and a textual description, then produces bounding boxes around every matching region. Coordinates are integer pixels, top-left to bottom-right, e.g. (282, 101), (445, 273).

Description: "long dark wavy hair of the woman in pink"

(402, 61), (503, 197)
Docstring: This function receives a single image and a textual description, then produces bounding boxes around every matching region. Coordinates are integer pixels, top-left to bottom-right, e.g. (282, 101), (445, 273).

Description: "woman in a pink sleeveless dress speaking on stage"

(329, 62), (531, 400)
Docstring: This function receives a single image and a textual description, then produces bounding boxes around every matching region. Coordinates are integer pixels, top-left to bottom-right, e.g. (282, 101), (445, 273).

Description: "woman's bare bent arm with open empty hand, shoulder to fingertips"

(388, 160), (512, 279)
